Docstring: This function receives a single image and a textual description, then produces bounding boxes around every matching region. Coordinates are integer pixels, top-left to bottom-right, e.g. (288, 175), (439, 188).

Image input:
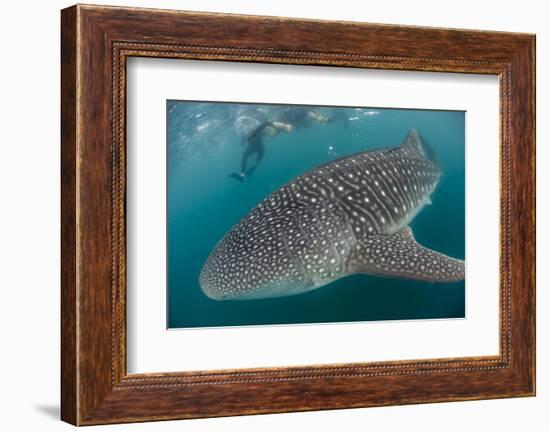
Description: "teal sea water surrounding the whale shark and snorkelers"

(167, 100), (465, 329)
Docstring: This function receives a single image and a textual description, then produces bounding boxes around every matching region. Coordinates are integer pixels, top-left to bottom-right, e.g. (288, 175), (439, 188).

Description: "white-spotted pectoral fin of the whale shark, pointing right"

(348, 226), (464, 282)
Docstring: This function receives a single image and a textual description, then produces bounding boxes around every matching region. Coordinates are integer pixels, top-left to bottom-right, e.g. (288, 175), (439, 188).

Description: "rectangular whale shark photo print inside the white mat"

(166, 100), (468, 329)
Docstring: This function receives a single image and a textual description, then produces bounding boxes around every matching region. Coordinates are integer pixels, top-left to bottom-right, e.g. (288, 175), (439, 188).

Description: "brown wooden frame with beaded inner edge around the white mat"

(61, 5), (535, 425)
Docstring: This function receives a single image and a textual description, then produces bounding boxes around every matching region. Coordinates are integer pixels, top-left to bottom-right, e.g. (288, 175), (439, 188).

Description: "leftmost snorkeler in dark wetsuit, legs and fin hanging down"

(229, 121), (292, 181)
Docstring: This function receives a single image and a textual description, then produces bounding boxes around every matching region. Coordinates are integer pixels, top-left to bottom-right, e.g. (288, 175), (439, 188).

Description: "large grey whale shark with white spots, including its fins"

(199, 129), (465, 300)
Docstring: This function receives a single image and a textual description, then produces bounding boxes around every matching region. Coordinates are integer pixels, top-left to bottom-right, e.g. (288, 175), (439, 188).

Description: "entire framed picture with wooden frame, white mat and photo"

(61, 5), (535, 425)
